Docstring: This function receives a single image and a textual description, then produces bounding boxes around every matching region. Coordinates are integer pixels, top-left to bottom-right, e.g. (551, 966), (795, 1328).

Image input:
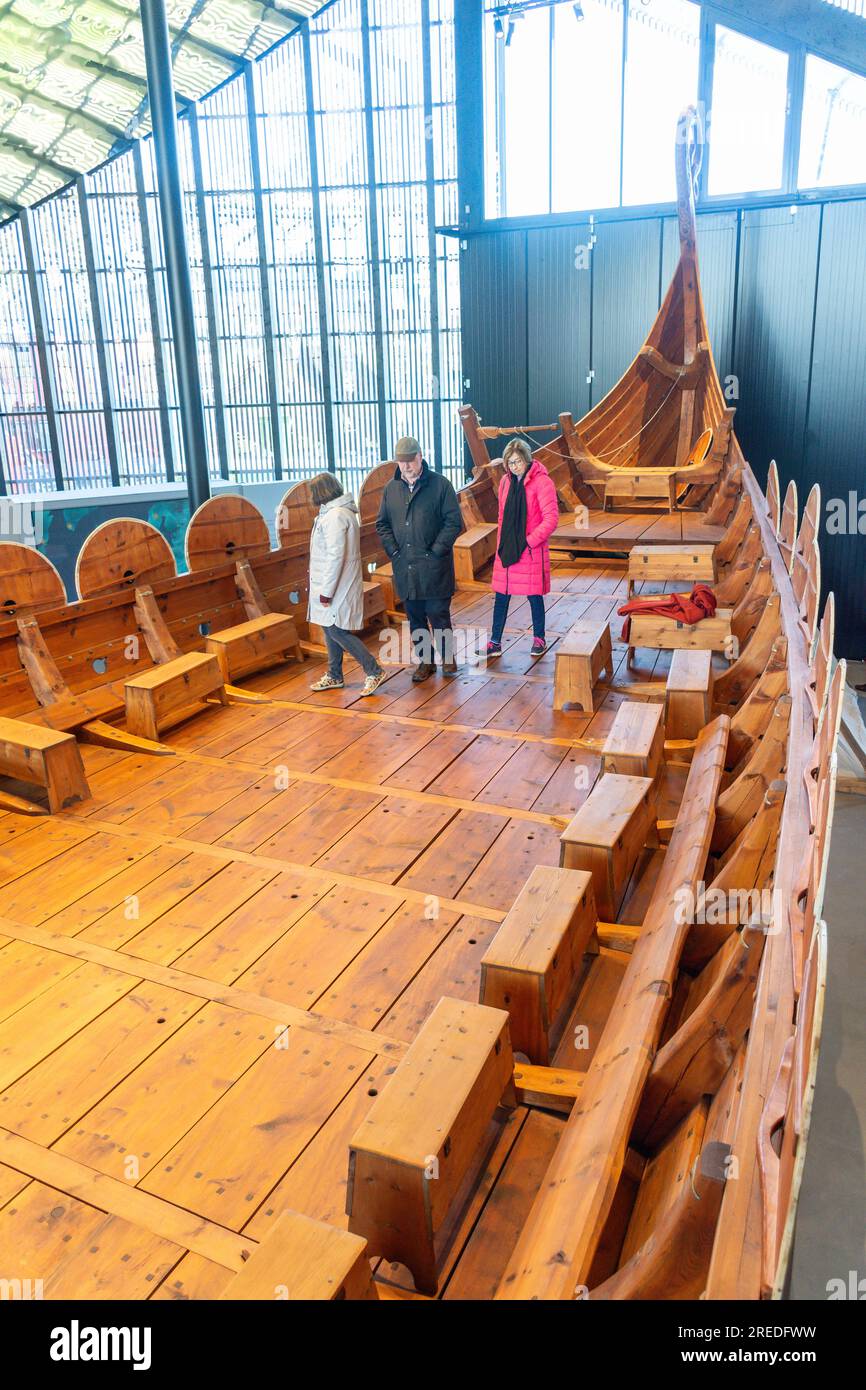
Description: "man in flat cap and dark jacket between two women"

(375, 438), (463, 685)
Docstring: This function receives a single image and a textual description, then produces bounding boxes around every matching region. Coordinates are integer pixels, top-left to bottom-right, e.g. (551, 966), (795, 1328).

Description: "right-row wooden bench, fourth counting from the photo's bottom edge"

(560, 773), (656, 922)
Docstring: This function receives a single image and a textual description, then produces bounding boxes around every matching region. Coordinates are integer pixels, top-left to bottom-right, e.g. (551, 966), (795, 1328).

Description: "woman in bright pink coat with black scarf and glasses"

(487, 439), (559, 656)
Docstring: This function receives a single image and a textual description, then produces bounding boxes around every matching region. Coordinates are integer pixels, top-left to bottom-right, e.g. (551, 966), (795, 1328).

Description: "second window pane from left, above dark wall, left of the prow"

(553, 0), (623, 213)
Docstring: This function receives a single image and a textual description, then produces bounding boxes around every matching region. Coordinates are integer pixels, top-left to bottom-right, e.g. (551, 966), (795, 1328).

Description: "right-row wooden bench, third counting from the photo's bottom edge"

(480, 865), (596, 1066)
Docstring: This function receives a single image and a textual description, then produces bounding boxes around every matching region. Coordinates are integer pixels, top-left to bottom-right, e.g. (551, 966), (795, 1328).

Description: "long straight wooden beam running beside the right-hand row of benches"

(496, 714), (730, 1301)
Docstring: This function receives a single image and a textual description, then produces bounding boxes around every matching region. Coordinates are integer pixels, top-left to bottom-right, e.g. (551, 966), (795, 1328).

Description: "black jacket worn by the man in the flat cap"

(375, 463), (463, 600)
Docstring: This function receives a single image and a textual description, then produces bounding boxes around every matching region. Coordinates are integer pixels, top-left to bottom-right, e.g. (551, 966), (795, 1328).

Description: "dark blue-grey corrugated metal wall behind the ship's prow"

(461, 202), (866, 657)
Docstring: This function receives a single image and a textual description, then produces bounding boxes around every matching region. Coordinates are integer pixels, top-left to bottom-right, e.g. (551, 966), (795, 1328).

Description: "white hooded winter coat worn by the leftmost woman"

(307, 496), (364, 632)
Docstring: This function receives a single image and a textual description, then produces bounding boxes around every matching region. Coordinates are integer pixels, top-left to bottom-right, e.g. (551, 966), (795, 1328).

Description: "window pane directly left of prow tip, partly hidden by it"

(623, 0), (701, 203)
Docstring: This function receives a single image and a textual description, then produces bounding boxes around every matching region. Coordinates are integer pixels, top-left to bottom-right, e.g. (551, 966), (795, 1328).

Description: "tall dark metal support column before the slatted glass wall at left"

(140, 0), (210, 512)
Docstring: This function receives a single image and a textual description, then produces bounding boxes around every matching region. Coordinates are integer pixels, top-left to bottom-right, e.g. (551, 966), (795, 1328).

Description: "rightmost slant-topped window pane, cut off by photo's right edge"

(798, 54), (866, 188)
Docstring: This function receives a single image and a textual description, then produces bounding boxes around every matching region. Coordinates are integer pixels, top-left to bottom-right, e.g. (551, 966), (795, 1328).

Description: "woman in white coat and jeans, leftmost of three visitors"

(309, 473), (386, 695)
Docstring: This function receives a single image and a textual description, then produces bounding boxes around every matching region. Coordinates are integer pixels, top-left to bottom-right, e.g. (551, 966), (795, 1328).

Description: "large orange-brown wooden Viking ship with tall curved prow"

(0, 113), (845, 1301)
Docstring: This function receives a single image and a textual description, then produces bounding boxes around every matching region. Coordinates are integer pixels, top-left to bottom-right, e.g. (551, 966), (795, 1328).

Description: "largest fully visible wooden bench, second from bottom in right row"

(346, 998), (514, 1294)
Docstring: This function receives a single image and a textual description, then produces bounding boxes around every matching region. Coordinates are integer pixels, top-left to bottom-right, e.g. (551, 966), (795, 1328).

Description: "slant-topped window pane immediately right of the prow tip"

(709, 24), (788, 193)
